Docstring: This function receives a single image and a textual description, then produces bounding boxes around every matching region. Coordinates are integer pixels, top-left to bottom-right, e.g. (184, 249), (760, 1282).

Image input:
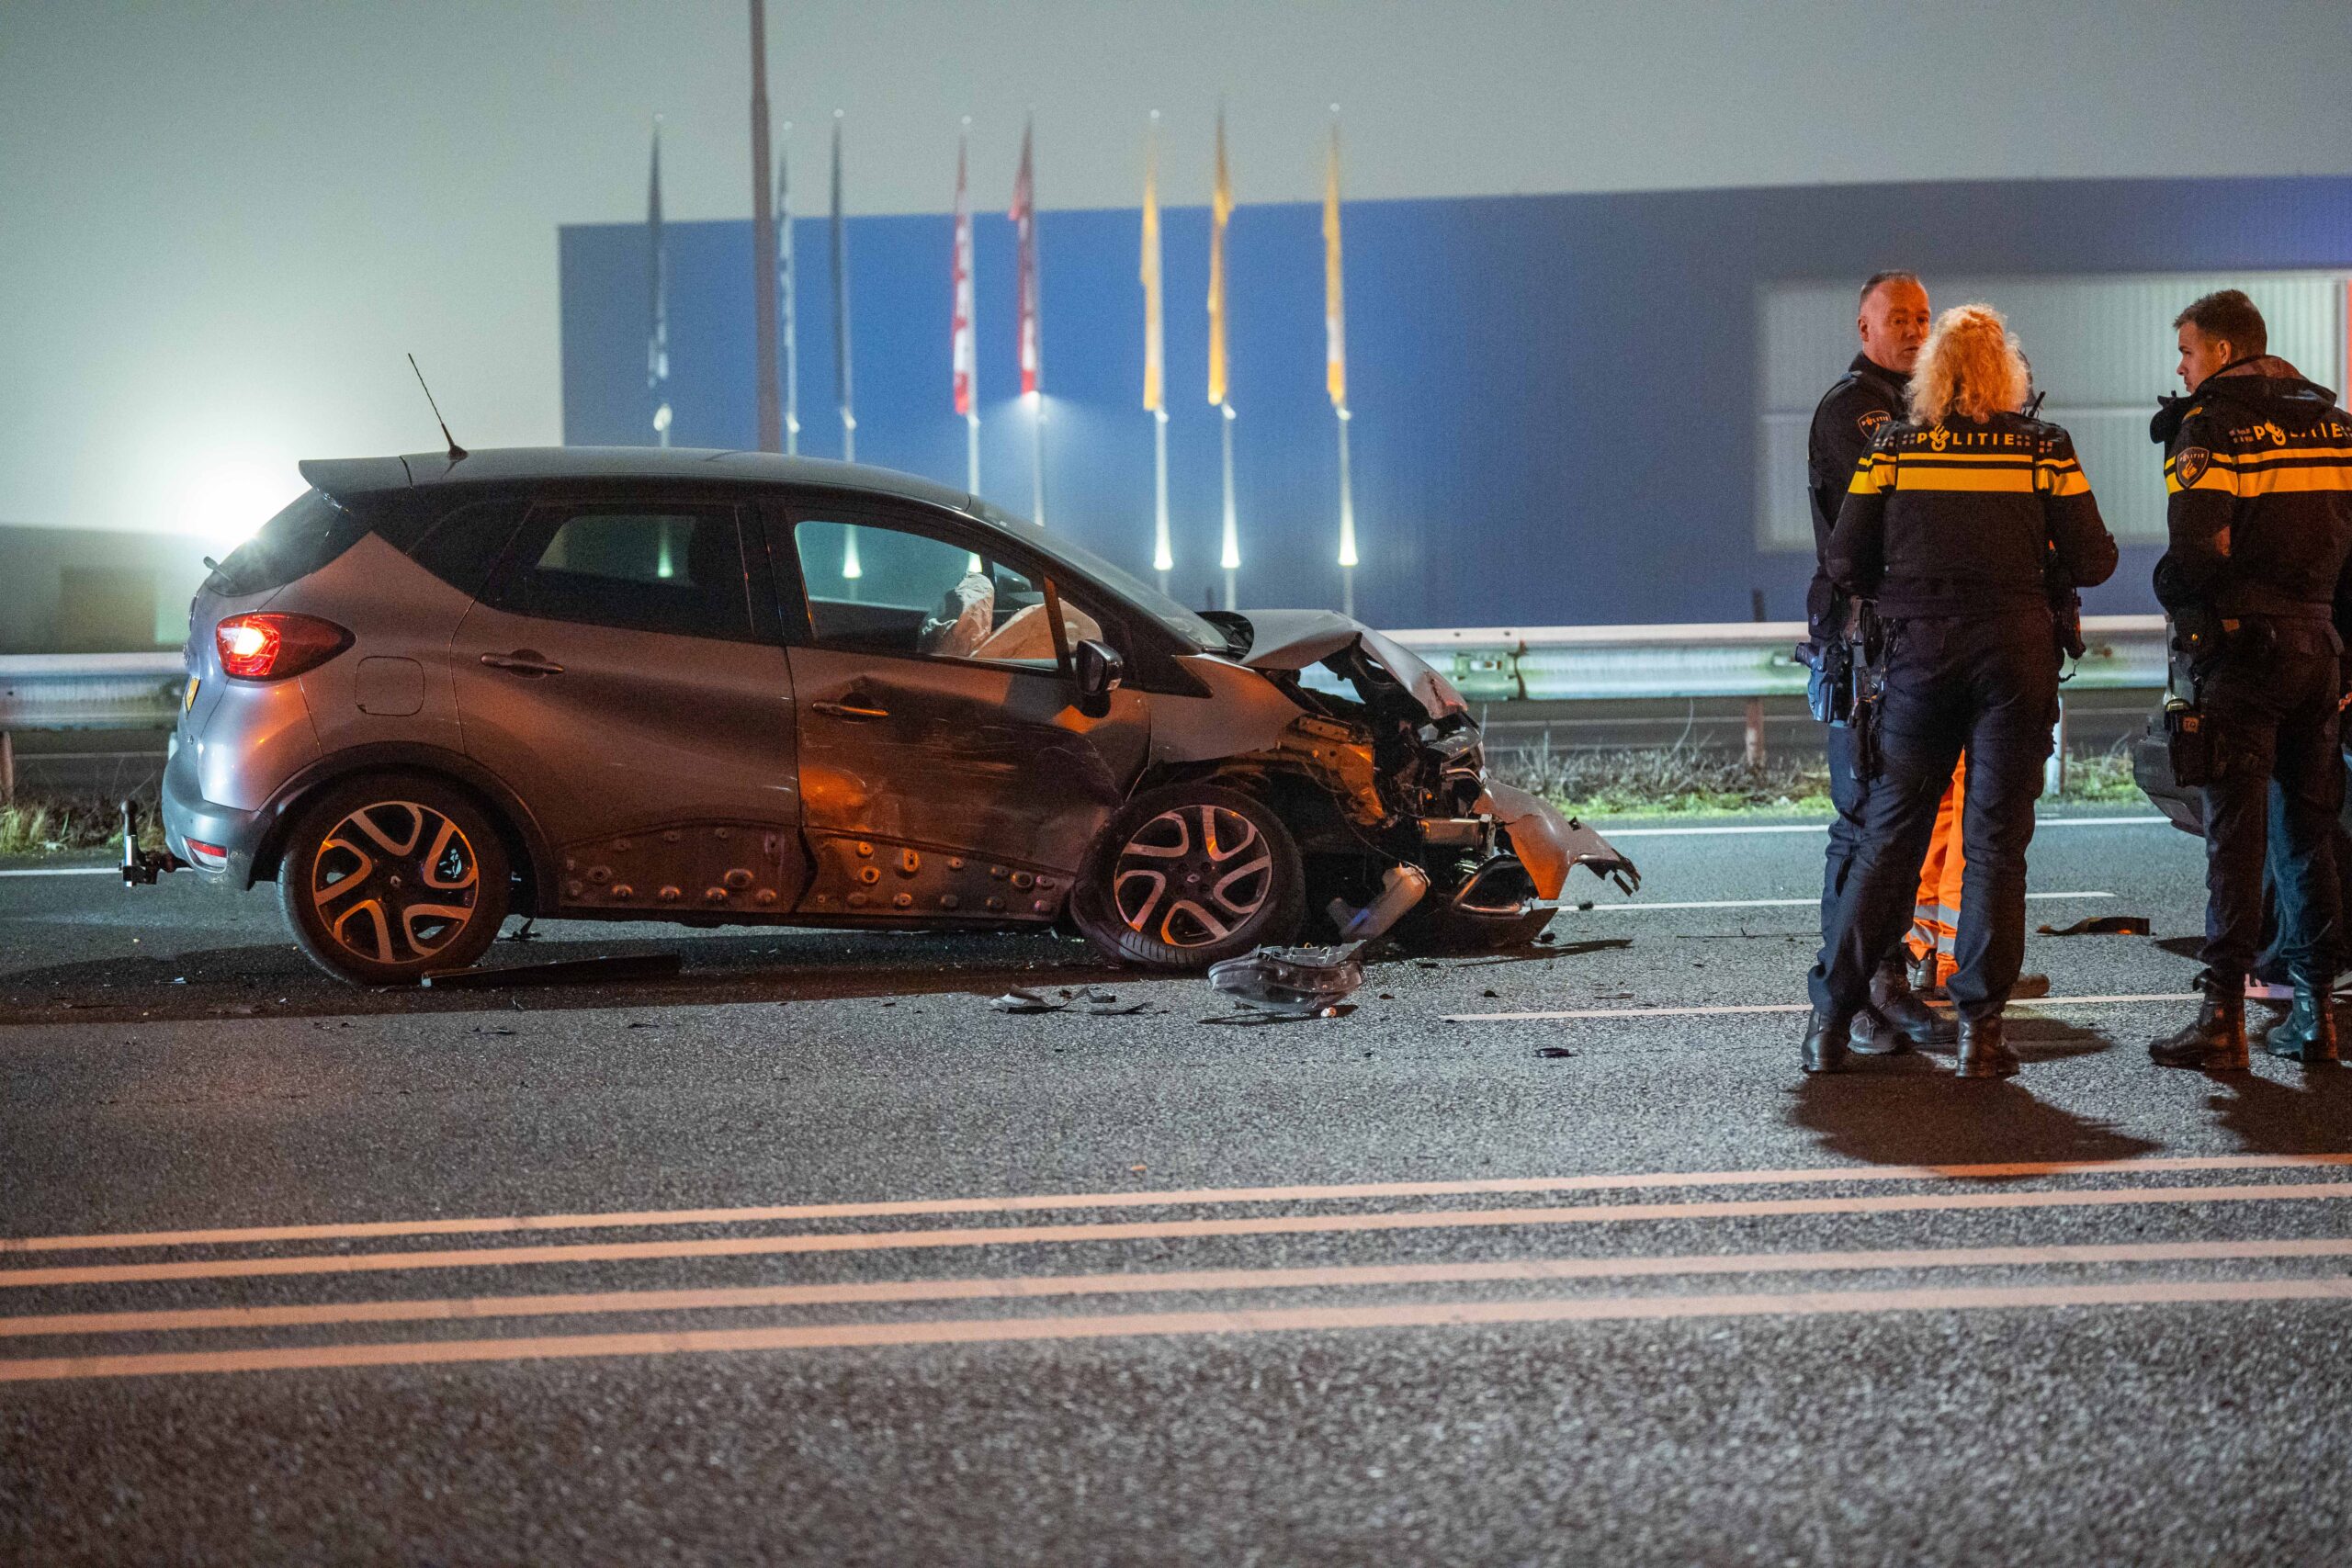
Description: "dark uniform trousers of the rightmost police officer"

(2199, 618), (2345, 992)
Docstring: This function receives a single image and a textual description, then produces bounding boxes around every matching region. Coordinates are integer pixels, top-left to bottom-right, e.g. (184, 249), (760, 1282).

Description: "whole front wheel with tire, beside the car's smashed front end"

(1070, 783), (1306, 971)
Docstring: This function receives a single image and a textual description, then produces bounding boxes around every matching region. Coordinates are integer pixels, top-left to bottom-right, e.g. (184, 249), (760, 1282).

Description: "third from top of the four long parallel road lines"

(0, 1236), (2352, 1337)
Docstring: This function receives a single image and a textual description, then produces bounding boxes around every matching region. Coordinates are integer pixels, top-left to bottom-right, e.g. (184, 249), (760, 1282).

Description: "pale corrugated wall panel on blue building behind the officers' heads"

(1755, 273), (2345, 550)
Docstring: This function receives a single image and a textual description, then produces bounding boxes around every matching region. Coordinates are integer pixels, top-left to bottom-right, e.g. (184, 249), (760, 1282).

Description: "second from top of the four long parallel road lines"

(0, 1180), (2352, 1288)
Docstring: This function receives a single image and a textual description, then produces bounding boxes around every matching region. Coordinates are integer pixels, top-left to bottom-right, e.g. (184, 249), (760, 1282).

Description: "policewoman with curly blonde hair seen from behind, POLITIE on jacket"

(1804, 306), (2114, 1079)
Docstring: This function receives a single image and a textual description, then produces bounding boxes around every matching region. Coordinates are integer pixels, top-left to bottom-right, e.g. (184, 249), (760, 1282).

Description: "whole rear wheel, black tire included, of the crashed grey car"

(277, 773), (511, 985)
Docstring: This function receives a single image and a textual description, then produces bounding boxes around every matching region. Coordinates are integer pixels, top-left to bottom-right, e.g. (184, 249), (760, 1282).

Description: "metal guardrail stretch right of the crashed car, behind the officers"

(1390, 616), (2164, 703)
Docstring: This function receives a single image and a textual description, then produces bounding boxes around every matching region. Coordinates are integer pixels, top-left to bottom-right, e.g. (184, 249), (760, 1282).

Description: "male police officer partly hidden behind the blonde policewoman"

(1804, 273), (1952, 1051)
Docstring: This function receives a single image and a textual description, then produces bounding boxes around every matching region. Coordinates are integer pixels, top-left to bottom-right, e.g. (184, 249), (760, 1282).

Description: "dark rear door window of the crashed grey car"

(496, 508), (752, 642)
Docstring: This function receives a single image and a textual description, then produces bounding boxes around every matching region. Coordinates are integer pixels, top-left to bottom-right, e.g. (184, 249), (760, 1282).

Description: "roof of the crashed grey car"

(301, 446), (981, 514)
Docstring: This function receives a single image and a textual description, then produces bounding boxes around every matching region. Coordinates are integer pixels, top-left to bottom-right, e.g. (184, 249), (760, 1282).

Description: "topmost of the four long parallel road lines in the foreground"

(18, 1152), (2352, 1256)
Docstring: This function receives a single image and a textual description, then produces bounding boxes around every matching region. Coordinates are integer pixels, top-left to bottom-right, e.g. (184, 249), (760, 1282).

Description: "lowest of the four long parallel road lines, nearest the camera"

(0, 1274), (2352, 1382)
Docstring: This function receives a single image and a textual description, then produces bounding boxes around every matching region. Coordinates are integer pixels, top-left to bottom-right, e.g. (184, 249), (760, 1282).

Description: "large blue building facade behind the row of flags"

(560, 179), (2352, 627)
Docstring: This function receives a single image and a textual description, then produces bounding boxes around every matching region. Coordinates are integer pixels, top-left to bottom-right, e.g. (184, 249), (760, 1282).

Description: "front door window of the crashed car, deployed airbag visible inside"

(793, 520), (1103, 670)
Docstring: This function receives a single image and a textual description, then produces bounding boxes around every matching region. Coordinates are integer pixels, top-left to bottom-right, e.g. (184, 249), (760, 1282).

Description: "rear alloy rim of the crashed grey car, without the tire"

(311, 799), (482, 964)
